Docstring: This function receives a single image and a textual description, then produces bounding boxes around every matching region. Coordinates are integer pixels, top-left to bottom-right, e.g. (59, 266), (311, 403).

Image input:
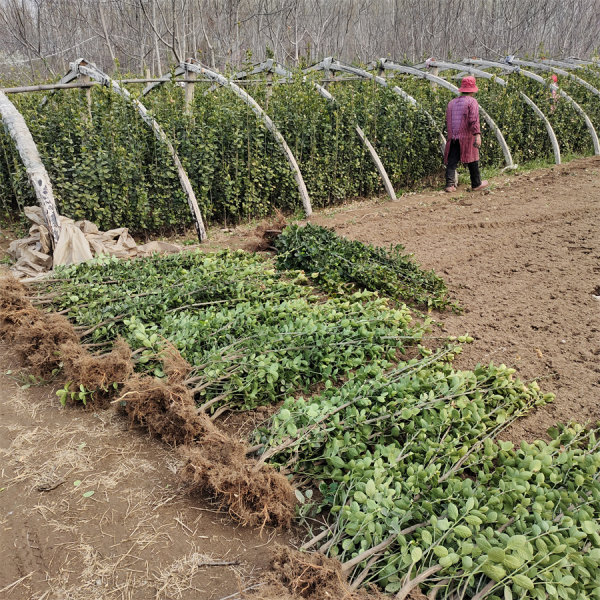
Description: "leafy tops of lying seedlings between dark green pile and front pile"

(43, 252), (423, 407)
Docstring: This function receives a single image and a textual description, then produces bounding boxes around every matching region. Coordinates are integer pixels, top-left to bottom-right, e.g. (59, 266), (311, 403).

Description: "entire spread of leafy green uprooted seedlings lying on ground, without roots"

(30, 228), (600, 600)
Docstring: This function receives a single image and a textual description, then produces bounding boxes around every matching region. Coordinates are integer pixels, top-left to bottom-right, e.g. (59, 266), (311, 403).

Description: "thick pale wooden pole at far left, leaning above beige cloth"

(0, 92), (60, 246)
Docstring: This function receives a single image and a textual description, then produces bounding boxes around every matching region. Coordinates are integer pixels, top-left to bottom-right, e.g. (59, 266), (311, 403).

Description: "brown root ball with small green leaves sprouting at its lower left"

(60, 338), (133, 398)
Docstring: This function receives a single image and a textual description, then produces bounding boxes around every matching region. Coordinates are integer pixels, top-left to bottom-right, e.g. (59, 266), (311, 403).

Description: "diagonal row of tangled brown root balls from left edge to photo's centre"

(0, 279), (295, 527)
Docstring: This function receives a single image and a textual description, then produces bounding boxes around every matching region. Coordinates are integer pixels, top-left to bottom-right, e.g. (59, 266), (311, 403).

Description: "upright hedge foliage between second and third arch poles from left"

(144, 78), (300, 222)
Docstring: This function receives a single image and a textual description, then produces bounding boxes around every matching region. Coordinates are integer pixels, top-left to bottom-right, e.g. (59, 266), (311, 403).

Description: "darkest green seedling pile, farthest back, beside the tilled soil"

(275, 224), (451, 308)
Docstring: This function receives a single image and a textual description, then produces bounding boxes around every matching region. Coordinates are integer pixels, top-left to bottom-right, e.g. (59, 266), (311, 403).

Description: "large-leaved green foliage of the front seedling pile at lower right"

(257, 358), (600, 599)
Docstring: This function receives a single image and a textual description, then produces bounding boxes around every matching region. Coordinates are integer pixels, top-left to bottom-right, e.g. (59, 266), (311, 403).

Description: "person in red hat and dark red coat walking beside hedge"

(444, 76), (489, 192)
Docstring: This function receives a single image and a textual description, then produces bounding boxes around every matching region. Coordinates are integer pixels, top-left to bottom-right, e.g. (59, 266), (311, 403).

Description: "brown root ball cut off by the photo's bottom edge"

(245, 546), (389, 600)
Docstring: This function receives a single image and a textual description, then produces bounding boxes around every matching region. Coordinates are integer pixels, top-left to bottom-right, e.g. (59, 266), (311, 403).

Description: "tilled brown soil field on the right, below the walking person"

(304, 157), (600, 440)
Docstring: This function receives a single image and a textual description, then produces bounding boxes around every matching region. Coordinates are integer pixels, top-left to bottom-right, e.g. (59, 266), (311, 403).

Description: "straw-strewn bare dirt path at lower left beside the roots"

(0, 346), (290, 600)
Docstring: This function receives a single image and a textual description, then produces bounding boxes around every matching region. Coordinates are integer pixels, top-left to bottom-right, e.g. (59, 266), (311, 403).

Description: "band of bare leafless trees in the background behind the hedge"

(0, 0), (600, 79)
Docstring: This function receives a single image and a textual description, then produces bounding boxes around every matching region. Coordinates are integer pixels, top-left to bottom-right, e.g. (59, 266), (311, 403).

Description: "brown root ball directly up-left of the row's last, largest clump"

(121, 375), (216, 445)
